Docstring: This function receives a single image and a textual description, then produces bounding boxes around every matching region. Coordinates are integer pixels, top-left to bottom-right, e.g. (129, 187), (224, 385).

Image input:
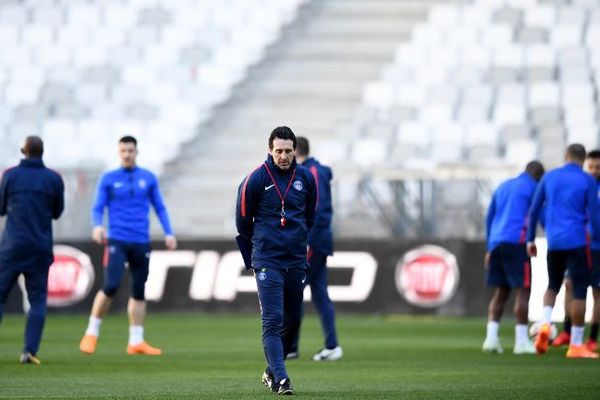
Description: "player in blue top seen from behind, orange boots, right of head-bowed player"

(527, 144), (600, 358)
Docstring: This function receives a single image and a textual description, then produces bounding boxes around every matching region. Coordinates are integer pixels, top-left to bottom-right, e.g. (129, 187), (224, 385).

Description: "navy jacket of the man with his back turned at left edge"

(0, 158), (65, 270)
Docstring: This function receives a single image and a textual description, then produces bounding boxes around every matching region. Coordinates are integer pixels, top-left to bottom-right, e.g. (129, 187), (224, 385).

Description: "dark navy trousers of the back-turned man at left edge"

(0, 267), (48, 354)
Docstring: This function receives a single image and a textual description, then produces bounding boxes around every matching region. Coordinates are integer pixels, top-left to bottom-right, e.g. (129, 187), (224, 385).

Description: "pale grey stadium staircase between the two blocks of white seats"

(162, 0), (433, 238)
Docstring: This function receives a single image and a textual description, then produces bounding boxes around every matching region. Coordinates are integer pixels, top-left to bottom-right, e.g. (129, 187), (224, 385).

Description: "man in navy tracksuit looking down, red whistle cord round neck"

(236, 126), (316, 394)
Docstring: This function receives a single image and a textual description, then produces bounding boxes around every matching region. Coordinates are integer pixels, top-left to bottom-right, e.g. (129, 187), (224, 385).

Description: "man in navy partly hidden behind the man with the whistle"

(287, 137), (343, 361)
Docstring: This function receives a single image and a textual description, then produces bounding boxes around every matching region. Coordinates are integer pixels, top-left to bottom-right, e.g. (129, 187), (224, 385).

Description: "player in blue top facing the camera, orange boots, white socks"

(79, 136), (177, 355)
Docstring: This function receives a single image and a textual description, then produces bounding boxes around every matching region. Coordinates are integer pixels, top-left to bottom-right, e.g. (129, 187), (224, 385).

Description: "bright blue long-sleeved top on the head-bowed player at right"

(487, 172), (537, 252)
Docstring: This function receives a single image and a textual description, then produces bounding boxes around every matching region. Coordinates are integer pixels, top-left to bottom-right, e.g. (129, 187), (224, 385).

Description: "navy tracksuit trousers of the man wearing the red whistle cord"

(254, 268), (306, 382)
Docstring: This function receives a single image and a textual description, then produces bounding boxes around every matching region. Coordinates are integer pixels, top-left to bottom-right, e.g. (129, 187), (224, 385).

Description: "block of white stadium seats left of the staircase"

(0, 0), (302, 172)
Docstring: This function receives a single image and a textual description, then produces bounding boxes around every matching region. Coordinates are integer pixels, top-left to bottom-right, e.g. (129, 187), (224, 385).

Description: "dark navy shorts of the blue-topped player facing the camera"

(102, 240), (151, 300)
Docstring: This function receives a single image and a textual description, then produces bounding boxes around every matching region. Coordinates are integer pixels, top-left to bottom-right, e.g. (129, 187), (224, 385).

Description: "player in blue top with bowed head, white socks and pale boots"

(483, 161), (544, 354)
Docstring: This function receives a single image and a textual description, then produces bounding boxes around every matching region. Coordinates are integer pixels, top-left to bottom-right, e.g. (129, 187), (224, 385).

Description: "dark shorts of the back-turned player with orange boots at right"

(546, 247), (592, 300)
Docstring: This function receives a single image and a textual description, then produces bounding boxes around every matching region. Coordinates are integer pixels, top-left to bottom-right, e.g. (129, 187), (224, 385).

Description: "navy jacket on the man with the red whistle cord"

(236, 154), (317, 268)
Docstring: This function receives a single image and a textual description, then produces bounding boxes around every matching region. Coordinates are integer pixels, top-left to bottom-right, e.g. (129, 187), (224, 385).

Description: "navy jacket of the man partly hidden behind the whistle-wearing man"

(302, 157), (333, 255)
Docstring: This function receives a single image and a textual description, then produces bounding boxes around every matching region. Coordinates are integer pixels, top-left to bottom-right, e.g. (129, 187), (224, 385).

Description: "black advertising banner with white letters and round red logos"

(5, 239), (489, 315)
